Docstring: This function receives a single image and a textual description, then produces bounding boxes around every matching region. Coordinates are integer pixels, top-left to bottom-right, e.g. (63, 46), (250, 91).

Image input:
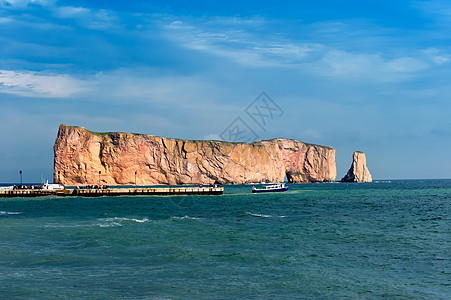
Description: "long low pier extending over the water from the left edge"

(0, 187), (224, 198)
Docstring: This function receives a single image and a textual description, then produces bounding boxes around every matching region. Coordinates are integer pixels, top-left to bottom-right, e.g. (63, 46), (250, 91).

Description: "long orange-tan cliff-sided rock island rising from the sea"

(54, 124), (336, 185)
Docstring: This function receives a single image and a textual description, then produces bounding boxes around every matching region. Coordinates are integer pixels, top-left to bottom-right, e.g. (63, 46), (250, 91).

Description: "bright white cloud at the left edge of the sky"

(0, 70), (86, 98)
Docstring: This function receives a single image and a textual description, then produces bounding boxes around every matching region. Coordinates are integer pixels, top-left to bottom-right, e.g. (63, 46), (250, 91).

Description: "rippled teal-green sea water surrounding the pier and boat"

(0, 180), (451, 299)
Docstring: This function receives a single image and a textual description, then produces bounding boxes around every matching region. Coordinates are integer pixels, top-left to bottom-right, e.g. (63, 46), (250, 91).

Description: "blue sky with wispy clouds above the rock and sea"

(0, 0), (451, 183)
